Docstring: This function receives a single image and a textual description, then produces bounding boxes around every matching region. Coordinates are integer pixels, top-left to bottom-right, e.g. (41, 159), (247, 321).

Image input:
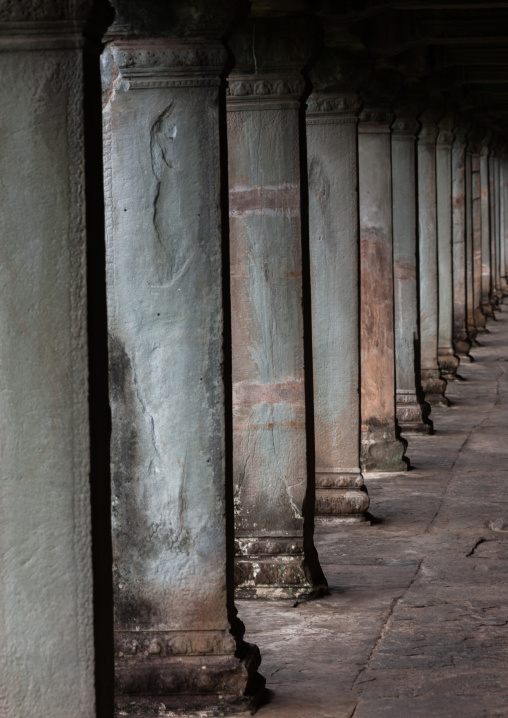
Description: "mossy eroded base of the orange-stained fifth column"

(360, 424), (409, 471)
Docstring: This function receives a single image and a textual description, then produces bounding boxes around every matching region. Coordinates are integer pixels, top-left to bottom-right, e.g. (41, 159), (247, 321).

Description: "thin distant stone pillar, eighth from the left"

(436, 117), (459, 378)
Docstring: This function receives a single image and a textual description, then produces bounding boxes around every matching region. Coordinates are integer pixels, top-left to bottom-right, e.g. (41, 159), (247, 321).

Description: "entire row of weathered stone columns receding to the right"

(0, 3), (508, 718)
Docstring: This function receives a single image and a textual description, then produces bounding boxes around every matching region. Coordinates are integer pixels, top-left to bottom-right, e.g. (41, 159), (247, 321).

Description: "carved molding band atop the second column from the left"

(109, 38), (227, 89)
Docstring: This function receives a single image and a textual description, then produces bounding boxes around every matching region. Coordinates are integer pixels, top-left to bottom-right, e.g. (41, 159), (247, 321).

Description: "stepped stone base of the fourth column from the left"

(314, 470), (370, 524)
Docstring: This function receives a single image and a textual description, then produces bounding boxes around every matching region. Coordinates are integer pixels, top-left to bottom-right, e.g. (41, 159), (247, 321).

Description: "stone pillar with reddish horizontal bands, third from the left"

(227, 18), (326, 598)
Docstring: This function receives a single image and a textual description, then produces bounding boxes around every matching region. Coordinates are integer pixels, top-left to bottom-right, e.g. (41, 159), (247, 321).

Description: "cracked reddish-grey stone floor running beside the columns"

(238, 307), (508, 718)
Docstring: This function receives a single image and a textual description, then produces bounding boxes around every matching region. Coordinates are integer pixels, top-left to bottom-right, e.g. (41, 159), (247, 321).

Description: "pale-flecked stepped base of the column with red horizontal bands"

(235, 536), (321, 599)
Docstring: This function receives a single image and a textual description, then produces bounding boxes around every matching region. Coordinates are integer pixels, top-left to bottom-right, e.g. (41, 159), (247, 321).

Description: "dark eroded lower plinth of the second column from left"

(114, 631), (265, 718)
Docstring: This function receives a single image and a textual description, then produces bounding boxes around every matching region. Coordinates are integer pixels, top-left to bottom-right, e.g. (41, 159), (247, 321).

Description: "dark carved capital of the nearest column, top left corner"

(0, 0), (92, 51)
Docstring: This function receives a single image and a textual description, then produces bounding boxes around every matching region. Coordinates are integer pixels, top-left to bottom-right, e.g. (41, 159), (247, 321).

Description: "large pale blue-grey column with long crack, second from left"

(102, 2), (262, 716)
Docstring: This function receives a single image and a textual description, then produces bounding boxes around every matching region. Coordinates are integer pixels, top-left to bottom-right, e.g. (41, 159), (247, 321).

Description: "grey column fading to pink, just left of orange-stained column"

(307, 73), (369, 524)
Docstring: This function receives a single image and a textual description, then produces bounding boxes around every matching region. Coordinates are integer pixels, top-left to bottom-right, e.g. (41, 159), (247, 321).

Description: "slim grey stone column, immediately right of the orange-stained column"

(392, 113), (432, 434)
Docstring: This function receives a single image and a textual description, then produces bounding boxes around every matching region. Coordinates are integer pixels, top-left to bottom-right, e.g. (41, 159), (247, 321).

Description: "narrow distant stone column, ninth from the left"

(452, 125), (471, 360)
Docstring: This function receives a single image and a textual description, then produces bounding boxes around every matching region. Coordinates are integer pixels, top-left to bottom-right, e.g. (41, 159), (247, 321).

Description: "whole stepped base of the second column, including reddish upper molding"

(114, 631), (265, 718)
